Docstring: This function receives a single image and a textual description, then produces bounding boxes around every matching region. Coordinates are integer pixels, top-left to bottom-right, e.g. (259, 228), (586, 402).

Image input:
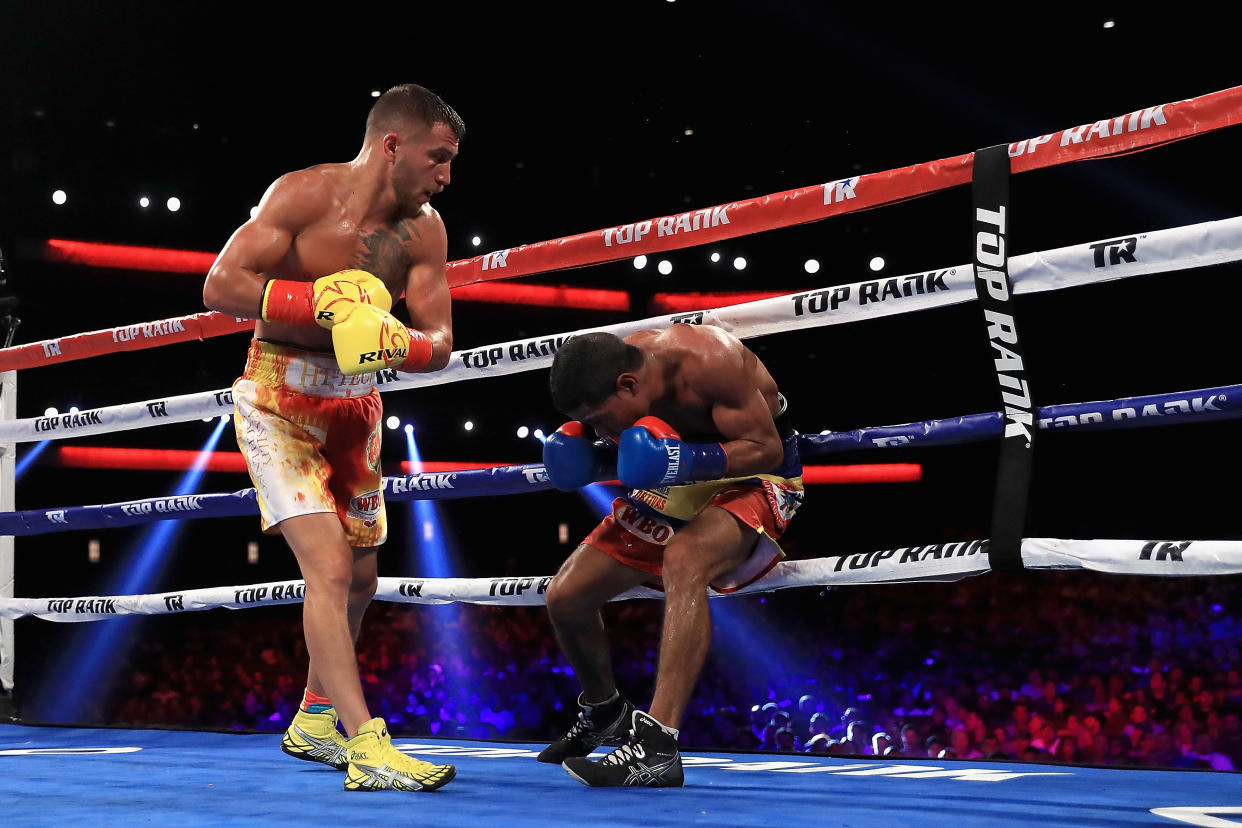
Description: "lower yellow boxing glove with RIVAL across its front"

(332, 303), (431, 375)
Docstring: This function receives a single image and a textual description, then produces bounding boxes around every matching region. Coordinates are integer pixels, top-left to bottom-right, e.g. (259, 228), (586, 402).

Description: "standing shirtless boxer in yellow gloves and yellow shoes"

(202, 84), (465, 791)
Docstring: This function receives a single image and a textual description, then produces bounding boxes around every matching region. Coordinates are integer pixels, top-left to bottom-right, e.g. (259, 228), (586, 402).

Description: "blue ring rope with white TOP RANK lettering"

(0, 385), (1242, 535)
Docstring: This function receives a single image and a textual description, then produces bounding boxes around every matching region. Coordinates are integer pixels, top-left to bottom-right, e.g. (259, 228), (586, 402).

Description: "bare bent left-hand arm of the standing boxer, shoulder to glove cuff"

(202, 170), (329, 319)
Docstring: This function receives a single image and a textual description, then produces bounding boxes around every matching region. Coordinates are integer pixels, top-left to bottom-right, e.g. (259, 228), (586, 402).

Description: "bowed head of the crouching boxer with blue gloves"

(548, 331), (651, 439)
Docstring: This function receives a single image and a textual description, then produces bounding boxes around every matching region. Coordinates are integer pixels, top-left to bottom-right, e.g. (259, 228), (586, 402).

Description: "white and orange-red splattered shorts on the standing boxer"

(232, 339), (388, 546)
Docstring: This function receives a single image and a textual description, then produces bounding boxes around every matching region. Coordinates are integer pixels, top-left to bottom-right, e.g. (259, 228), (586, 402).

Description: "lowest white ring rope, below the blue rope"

(0, 538), (1242, 621)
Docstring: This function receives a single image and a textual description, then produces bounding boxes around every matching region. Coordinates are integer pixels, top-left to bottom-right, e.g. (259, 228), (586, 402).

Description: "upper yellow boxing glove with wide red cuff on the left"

(258, 271), (392, 329)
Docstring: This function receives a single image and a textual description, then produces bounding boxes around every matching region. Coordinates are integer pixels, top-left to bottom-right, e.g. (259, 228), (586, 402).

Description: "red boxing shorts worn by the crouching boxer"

(582, 433), (805, 592)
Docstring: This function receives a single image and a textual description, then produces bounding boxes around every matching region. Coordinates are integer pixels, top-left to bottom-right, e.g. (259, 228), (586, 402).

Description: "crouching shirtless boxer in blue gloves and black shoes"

(539, 325), (802, 787)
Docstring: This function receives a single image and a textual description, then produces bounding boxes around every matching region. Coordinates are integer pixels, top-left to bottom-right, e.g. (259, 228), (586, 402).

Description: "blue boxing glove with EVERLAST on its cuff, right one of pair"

(617, 417), (729, 489)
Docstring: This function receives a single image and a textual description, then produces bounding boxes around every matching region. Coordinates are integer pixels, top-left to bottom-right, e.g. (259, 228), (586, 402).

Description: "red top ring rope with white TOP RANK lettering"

(0, 87), (1242, 370)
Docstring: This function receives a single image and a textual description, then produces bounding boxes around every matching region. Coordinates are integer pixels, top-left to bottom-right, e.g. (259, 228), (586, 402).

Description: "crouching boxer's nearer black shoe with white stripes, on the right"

(561, 710), (686, 788)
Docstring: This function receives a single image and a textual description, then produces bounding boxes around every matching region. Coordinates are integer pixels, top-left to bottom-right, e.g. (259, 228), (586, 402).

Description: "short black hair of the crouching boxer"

(548, 331), (650, 414)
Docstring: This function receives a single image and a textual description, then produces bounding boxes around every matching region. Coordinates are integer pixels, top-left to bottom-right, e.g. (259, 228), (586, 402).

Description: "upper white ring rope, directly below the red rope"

(0, 216), (1242, 443)
